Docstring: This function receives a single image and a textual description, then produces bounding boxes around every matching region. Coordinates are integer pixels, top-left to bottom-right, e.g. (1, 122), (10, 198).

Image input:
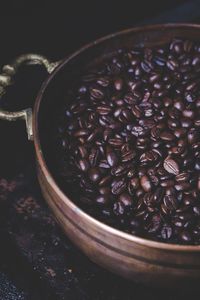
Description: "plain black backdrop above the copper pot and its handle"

(0, 0), (200, 62)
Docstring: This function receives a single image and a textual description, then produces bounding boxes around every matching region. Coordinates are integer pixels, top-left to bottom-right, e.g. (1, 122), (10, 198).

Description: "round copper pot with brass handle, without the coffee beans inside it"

(0, 24), (200, 286)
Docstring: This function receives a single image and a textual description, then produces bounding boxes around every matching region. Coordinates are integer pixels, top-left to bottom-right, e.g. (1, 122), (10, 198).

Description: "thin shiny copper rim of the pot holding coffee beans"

(33, 23), (200, 252)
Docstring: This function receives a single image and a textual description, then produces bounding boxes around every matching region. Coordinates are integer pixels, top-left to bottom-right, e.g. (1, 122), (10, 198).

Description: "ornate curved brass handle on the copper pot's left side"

(0, 54), (60, 140)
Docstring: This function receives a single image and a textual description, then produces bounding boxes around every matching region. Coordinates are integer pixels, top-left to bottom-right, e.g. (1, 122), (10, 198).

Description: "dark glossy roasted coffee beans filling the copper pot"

(55, 38), (200, 244)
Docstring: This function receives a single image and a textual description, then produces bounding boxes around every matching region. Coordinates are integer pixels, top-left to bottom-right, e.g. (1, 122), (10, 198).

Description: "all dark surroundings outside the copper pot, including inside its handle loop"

(0, 0), (200, 300)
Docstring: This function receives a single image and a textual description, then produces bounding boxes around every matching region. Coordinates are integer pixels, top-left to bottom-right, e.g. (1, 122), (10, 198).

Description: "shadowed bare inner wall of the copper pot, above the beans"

(37, 24), (200, 248)
